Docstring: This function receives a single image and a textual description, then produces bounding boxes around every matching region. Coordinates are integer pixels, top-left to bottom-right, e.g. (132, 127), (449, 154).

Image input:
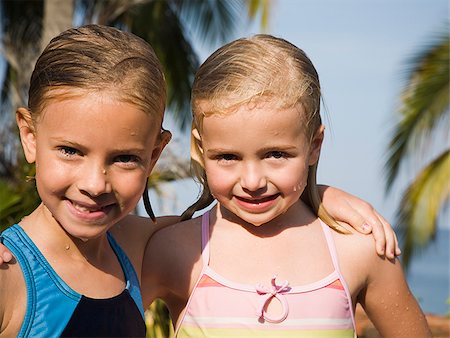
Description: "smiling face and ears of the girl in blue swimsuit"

(17, 92), (169, 239)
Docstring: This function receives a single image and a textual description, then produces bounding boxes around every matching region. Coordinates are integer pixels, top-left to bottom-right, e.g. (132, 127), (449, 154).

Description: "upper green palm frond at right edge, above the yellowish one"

(385, 27), (450, 191)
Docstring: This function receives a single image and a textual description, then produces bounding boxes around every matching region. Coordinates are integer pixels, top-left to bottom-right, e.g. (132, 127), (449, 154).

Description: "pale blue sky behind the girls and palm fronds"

(149, 0), (449, 231)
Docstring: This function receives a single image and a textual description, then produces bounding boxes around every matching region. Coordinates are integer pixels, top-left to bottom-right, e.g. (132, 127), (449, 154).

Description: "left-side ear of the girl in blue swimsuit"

(16, 108), (36, 163)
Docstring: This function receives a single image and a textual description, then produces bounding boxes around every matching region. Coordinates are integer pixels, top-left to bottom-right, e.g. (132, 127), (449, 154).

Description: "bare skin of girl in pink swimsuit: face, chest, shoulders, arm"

(142, 103), (430, 337)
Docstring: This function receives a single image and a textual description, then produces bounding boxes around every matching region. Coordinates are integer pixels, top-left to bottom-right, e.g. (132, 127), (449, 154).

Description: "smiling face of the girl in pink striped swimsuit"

(198, 103), (323, 226)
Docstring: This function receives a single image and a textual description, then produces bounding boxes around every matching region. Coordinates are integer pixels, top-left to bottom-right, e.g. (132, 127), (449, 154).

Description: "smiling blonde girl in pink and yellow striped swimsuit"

(143, 35), (430, 338)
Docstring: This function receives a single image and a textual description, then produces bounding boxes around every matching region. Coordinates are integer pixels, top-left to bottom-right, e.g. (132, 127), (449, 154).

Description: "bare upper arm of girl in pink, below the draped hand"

(358, 257), (432, 338)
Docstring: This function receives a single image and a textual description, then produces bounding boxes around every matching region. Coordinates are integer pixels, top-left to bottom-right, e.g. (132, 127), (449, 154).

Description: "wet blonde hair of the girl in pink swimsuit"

(182, 34), (342, 232)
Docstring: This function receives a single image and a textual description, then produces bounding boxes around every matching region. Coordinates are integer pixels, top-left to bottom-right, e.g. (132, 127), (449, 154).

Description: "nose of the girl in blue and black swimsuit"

(78, 165), (111, 197)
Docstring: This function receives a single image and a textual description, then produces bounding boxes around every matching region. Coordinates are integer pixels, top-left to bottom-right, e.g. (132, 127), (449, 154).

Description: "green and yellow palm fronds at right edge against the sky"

(386, 25), (450, 266)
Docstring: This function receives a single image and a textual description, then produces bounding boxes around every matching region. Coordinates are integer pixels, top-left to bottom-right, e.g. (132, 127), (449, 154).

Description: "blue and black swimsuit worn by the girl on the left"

(0, 224), (145, 338)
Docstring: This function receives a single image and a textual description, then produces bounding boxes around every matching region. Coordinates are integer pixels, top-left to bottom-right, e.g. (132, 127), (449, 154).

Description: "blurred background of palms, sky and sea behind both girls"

(0, 0), (450, 337)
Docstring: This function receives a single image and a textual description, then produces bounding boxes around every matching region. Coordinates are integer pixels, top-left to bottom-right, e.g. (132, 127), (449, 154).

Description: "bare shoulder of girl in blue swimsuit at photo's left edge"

(0, 258), (26, 337)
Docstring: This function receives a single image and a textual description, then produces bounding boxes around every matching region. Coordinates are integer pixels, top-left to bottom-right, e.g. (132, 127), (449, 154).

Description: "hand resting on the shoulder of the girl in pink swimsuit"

(318, 185), (401, 259)
